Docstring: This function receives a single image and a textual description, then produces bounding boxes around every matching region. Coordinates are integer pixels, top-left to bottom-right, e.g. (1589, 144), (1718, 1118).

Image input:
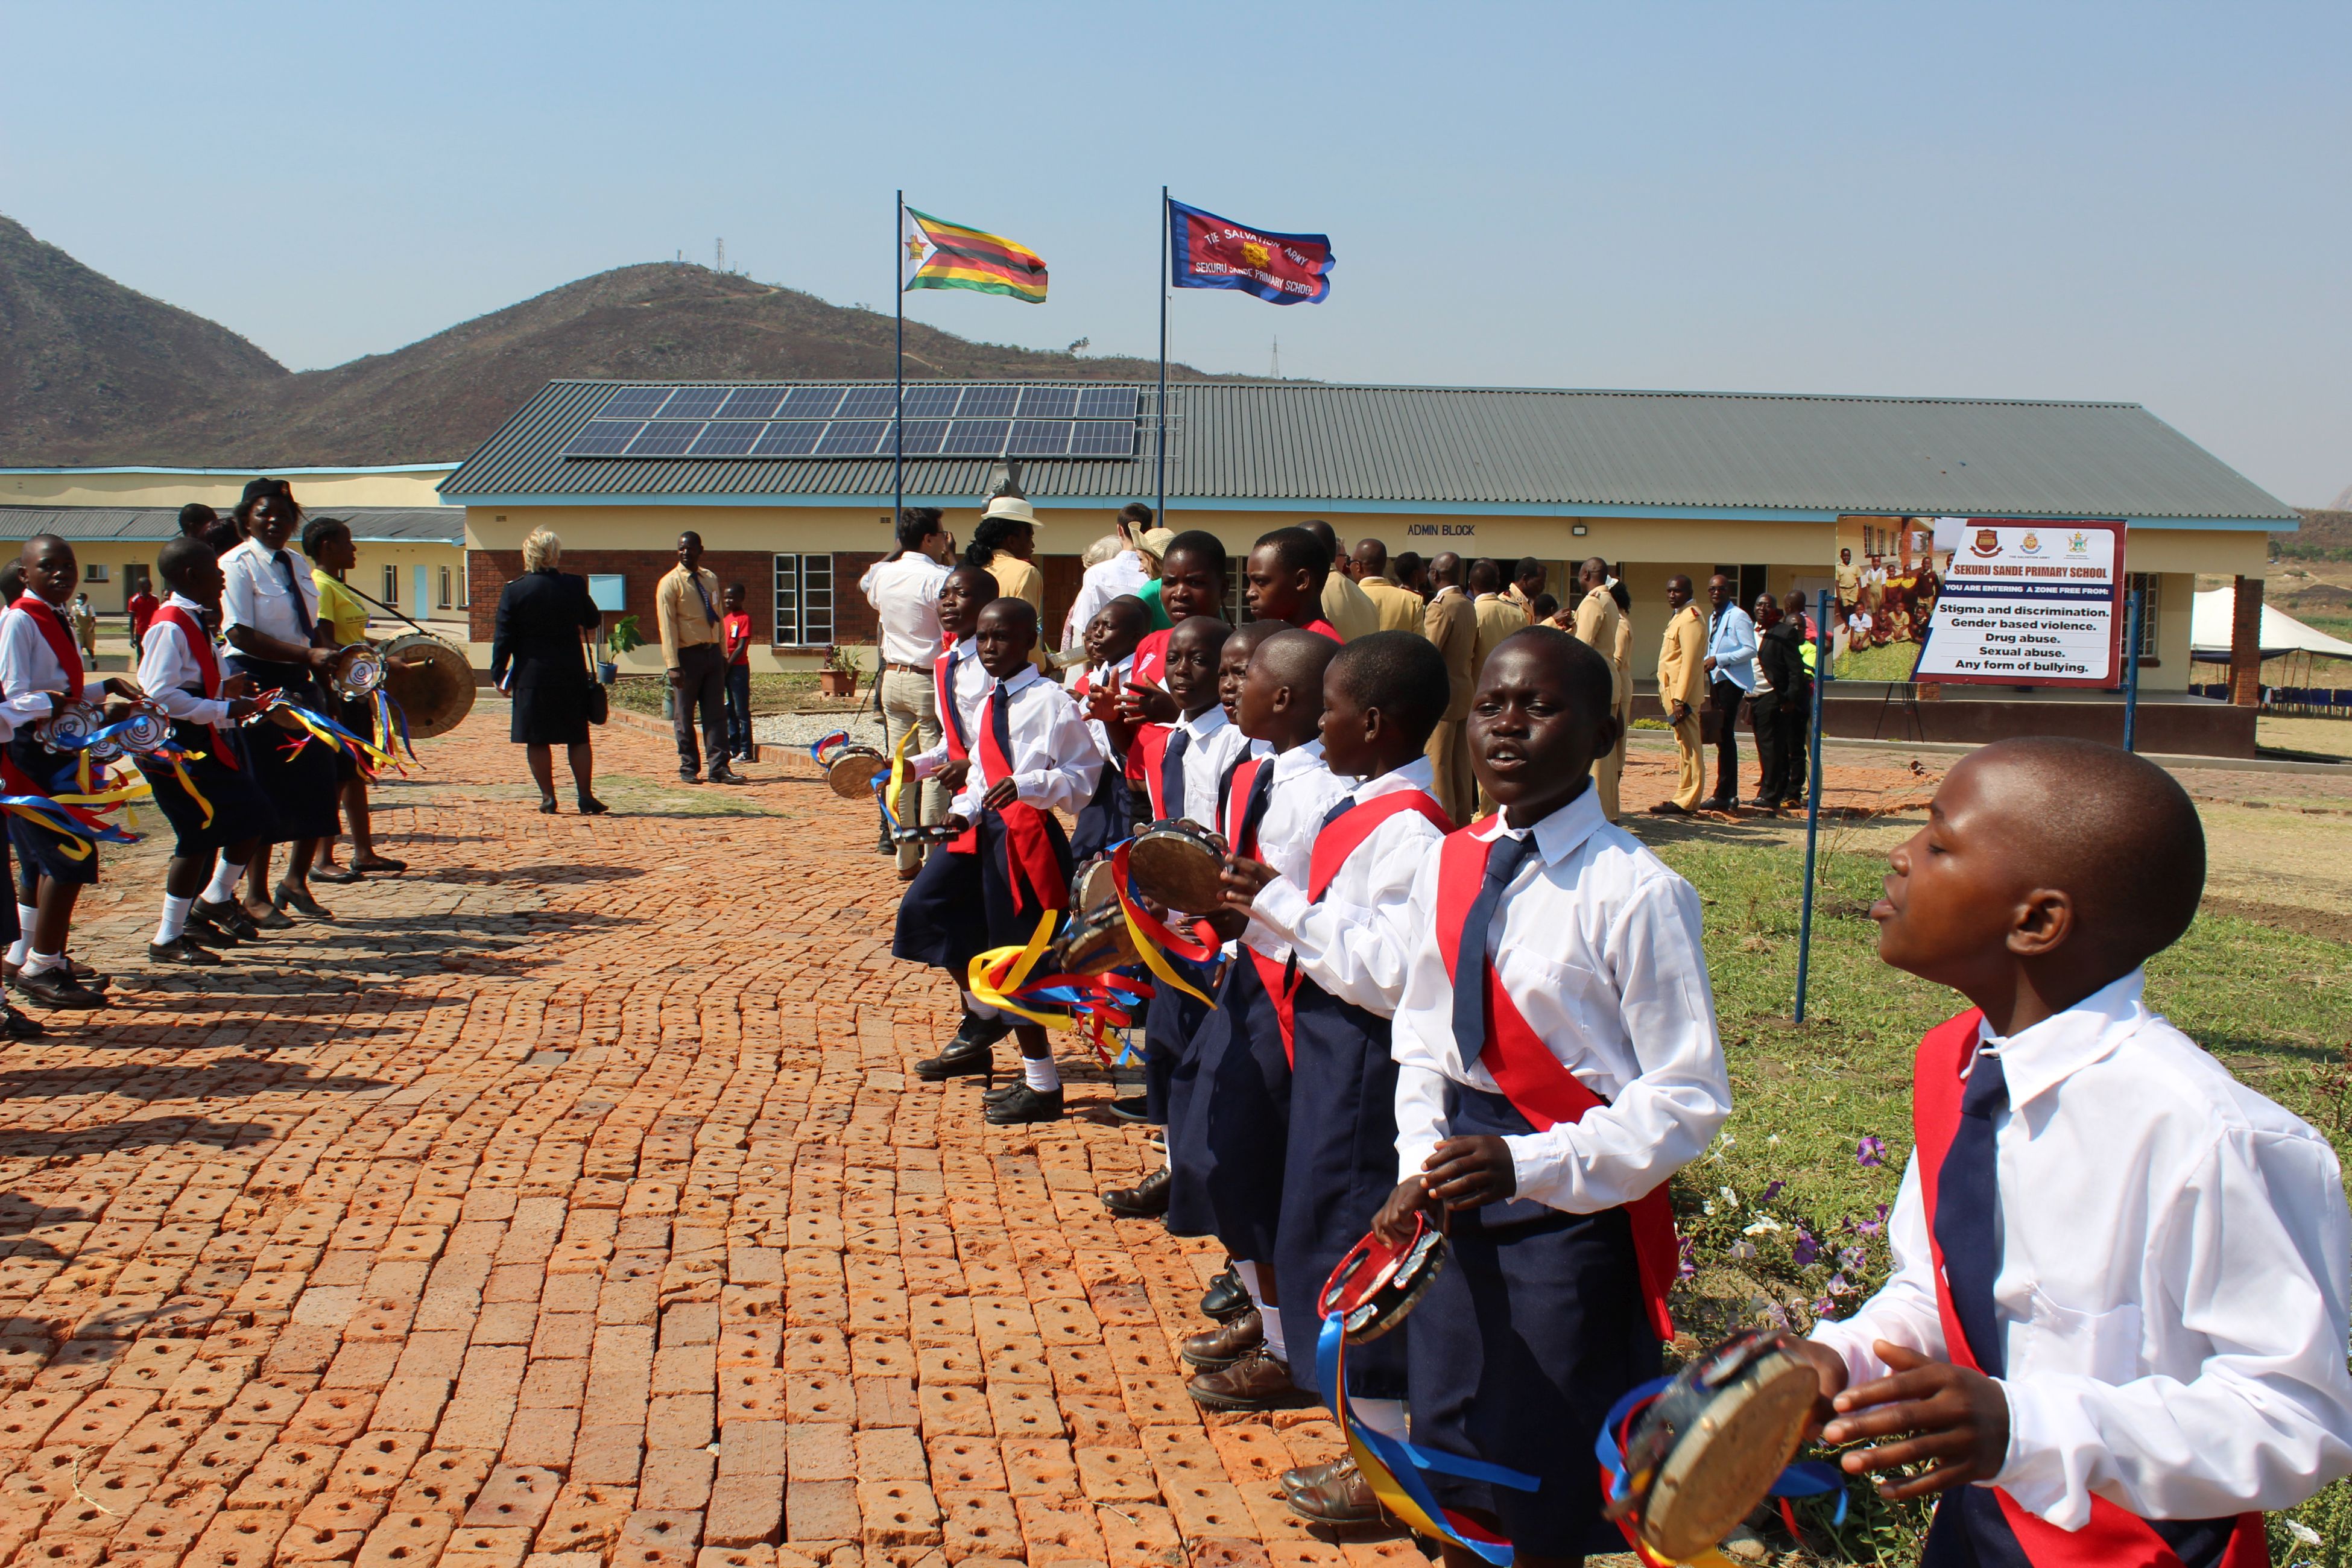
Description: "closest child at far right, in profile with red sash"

(1806, 738), (2352, 1568)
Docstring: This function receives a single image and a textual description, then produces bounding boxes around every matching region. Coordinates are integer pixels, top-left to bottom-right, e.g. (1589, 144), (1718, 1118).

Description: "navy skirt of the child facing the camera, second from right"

(1402, 1086), (1660, 1557)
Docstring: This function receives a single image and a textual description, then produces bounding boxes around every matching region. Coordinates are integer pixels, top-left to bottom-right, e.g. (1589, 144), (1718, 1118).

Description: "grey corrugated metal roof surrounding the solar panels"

(440, 381), (2295, 522)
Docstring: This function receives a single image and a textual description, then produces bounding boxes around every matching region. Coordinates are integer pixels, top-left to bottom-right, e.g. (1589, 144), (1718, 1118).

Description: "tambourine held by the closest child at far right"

(1609, 1330), (1821, 1563)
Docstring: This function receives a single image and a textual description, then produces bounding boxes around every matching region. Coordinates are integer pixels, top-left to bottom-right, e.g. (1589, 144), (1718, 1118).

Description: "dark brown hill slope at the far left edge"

(0, 219), (294, 463)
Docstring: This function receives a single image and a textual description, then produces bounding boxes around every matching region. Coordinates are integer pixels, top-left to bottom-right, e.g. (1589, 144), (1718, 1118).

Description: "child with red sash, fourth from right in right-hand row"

(1169, 628), (1348, 1411)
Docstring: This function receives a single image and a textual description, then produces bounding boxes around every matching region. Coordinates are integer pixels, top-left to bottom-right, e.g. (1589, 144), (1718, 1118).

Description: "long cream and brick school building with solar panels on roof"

(440, 381), (2295, 752)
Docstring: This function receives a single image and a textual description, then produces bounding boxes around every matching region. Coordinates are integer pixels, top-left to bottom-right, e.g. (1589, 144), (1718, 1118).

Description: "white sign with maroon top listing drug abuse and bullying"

(1912, 517), (2124, 689)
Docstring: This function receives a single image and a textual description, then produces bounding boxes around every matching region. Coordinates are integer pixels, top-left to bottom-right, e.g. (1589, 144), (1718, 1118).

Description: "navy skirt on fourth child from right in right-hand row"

(1169, 947), (1312, 1260)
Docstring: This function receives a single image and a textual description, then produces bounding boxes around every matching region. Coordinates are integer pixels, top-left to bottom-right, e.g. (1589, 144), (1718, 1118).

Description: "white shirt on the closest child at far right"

(1813, 971), (2352, 1531)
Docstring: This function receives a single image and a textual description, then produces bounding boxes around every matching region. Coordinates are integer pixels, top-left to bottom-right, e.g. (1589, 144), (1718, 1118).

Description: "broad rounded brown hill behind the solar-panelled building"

(13, 219), (1232, 468)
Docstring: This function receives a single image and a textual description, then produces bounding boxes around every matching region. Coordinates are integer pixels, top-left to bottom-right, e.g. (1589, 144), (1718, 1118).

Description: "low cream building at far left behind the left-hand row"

(0, 463), (466, 639)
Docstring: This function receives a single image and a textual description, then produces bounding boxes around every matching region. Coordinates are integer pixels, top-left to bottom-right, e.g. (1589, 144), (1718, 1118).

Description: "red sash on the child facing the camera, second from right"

(1437, 827), (1682, 1340)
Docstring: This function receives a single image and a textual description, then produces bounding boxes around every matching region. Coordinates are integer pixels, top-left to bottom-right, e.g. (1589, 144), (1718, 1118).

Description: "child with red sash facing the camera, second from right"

(1350, 628), (1731, 1568)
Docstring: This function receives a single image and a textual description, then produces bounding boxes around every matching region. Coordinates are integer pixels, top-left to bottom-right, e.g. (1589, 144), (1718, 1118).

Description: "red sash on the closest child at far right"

(1912, 1006), (2270, 1568)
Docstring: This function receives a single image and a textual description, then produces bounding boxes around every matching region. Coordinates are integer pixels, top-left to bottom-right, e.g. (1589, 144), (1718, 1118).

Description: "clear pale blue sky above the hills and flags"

(0, 0), (2352, 505)
